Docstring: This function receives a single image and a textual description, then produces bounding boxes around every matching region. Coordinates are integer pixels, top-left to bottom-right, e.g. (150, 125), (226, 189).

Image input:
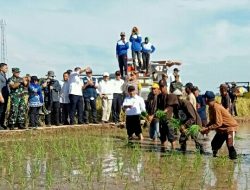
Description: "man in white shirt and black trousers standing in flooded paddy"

(123, 86), (146, 140)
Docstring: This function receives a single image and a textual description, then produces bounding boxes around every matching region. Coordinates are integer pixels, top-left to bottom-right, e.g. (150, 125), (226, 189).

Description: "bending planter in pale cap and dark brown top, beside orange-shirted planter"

(173, 89), (204, 154)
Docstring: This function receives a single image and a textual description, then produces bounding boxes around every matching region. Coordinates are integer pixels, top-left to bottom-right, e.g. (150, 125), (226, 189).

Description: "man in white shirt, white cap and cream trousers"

(98, 72), (113, 123)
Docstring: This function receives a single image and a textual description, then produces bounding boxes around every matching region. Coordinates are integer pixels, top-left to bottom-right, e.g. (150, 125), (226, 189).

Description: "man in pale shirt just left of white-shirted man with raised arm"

(59, 72), (70, 125)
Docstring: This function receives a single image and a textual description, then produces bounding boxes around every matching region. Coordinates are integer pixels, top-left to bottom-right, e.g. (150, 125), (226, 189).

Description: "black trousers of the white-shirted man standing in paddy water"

(126, 115), (142, 137)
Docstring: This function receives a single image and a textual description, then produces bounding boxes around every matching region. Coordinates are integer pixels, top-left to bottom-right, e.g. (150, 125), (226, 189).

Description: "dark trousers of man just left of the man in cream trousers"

(83, 98), (97, 123)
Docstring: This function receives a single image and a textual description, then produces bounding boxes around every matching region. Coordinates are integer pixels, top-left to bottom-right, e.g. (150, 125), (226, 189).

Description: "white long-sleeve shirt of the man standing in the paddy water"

(122, 95), (146, 115)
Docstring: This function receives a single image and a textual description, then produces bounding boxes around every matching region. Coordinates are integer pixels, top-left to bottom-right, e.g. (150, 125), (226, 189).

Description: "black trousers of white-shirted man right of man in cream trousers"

(112, 93), (123, 123)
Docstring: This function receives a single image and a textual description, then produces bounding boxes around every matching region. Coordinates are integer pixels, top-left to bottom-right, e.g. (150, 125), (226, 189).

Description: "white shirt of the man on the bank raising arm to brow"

(69, 72), (83, 96)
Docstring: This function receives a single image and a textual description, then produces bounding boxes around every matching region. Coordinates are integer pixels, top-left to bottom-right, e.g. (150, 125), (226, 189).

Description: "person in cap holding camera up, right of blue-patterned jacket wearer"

(42, 71), (61, 127)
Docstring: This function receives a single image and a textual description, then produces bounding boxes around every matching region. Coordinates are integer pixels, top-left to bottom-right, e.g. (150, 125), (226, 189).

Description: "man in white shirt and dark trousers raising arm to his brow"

(69, 67), (85, 125)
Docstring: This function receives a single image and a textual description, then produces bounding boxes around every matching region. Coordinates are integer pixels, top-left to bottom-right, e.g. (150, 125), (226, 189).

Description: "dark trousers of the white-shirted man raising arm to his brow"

(69, 94), (83, 125)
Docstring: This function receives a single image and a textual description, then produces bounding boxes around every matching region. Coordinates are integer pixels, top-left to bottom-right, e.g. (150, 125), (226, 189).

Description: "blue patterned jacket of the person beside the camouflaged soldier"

(28, 83), (43, 107)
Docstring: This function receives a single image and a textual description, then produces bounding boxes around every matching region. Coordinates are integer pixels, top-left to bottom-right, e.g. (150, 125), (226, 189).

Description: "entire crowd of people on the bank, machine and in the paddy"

(0, 27), (238, 159)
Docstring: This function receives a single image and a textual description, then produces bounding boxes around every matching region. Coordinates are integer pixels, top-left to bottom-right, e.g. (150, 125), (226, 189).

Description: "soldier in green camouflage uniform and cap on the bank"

(8, 68), (28, 130)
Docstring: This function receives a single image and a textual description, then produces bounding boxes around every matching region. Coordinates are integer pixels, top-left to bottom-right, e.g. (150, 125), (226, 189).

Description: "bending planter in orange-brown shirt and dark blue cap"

(201, 91), (239, 159)
